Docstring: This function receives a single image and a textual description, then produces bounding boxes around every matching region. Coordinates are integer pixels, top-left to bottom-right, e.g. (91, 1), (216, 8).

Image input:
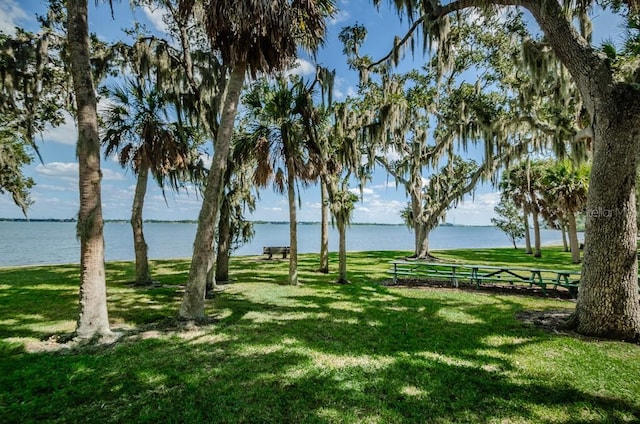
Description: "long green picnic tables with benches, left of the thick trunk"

(388, 260), (580, 296)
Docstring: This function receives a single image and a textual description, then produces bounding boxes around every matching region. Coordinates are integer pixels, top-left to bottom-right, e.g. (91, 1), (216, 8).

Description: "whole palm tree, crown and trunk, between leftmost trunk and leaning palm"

(102, 79), (202, 285)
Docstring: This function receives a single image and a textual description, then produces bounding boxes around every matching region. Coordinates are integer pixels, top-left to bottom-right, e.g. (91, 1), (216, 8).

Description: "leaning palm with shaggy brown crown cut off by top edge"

(179, 0), (334, 319)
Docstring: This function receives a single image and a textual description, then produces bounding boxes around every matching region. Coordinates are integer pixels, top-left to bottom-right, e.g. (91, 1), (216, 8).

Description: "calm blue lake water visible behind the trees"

(0, 222), (562, 266)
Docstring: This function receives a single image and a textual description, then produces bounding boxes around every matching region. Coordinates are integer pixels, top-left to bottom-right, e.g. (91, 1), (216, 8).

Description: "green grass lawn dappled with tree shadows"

(0, 248), (640, 423)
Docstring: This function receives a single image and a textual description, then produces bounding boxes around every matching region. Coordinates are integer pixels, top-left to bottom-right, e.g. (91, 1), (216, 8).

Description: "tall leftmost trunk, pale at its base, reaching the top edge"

(67, 0), (112, 339)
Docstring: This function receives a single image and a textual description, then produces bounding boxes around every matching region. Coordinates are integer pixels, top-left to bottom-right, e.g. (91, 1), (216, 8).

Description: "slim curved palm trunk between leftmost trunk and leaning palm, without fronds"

(131, 166), (151, 286)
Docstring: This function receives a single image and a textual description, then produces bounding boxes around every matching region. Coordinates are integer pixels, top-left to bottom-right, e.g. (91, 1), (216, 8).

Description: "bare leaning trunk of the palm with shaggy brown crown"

(178, 64), (247, 319)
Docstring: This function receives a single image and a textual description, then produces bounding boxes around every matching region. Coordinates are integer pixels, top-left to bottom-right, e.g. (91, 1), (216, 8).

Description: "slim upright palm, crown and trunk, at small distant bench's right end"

(239, 77), (318, 285)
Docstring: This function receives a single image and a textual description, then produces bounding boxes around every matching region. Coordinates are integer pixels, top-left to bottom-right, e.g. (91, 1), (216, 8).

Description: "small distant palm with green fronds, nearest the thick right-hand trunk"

(543, 160), (589, 264)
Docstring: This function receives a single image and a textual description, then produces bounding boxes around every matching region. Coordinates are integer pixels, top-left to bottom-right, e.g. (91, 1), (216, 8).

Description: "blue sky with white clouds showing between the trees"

(0, 0), (623, 225)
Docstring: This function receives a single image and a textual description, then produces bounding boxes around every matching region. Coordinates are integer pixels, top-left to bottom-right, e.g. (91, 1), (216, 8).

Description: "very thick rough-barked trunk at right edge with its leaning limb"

(523, 1), (640, 341)
